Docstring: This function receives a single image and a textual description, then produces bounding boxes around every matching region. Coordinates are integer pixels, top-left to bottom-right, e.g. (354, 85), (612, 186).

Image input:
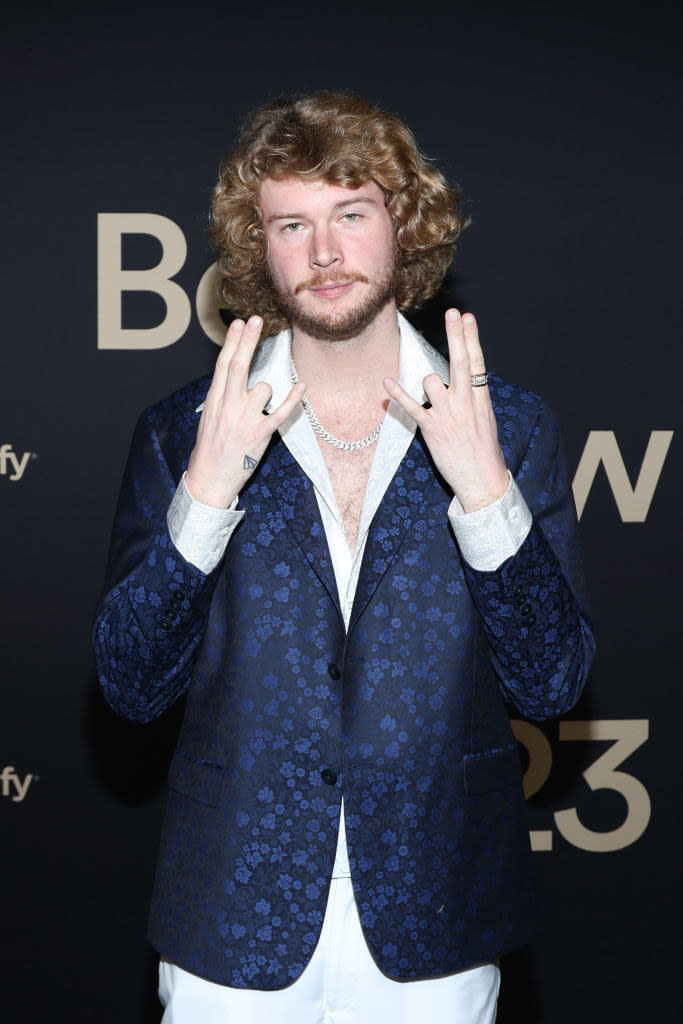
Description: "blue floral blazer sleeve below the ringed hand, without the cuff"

(464, 403), (595, 720)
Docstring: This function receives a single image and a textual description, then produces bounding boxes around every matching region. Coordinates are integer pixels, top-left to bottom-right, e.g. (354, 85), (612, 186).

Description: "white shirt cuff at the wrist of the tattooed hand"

(166, 473), (245, 573)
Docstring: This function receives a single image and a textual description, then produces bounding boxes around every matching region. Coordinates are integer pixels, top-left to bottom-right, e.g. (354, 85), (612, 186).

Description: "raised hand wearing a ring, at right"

(384, 309), (509, 512)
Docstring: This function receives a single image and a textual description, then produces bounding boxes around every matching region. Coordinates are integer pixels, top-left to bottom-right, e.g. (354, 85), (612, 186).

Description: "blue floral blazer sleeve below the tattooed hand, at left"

(93, 411), (217, 722)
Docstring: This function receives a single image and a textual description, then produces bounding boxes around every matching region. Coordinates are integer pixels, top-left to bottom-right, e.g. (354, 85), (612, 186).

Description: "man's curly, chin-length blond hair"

(209, 91), (467, 336)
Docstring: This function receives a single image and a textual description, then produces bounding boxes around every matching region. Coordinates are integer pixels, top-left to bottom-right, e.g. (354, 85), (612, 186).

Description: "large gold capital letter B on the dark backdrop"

(97, 213), (191, 349)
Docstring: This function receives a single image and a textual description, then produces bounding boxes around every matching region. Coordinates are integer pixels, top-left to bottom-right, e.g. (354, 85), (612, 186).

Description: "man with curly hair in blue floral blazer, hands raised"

(95, 93), (593, 1024)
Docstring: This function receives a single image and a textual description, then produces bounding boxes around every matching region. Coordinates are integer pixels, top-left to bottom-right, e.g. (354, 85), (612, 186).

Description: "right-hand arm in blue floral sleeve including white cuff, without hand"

(450, 410), (595, 719)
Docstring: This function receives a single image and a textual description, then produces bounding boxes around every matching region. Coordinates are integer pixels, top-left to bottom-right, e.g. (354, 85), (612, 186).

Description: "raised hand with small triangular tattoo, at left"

(185, 316), (306, 509)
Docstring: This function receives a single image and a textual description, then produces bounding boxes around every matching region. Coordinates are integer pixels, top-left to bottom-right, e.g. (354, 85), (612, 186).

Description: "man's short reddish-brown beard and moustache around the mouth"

(270, 252), (398, 341)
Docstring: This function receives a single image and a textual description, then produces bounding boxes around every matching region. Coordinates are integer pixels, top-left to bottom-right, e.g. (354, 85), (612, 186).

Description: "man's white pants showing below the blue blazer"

(159, 878), (500, 1024)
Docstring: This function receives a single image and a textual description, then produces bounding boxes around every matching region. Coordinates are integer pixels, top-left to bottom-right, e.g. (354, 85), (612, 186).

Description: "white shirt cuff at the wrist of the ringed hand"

(449, 470), (531, 572)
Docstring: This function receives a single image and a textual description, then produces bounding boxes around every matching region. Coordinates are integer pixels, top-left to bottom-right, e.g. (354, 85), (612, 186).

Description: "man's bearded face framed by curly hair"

(259, 177), (396, 341)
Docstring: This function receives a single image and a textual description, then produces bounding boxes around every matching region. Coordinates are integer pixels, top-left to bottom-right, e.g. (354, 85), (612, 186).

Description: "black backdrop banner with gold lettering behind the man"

(0, 0), (683, 1024)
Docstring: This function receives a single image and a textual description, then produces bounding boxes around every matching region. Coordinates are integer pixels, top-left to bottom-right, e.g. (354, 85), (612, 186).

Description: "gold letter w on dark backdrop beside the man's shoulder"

(572, 430), (674, 522)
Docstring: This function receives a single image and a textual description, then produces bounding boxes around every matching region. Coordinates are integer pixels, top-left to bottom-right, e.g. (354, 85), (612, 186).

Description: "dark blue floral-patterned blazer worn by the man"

(94, 374), (594, 989)
